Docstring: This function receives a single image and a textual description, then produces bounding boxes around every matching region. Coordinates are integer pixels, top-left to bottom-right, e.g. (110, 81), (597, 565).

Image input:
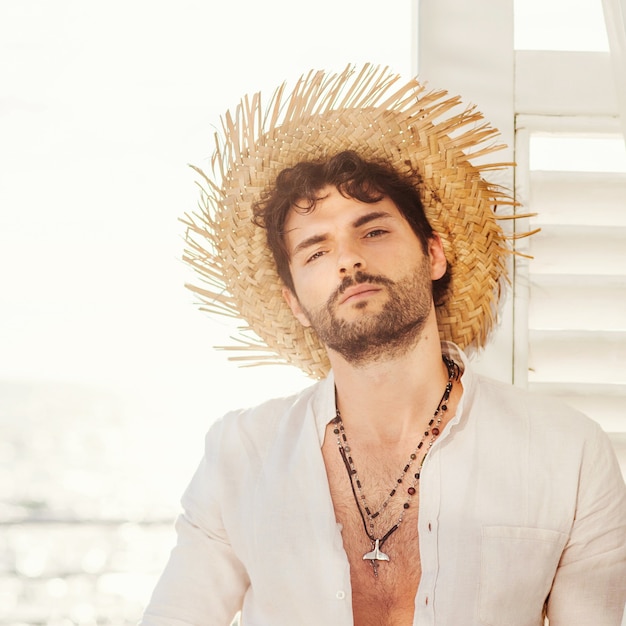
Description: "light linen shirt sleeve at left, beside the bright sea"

(140, 414), (249, 626)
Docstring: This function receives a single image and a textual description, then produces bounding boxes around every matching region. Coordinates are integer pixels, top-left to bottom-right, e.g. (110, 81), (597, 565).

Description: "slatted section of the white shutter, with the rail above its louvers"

(514, 52), (626, 474)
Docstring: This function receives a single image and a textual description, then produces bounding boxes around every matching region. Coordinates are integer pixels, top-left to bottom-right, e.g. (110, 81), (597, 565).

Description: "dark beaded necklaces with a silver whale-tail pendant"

(332, 355), (460, 577)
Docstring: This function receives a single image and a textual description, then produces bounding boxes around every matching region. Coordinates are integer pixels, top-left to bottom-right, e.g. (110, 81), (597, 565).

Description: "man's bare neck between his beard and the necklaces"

(330, 326), (448, 445)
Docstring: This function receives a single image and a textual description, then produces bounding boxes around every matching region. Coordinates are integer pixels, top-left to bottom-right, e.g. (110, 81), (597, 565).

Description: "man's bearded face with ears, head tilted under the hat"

(285, 187), (445, 363)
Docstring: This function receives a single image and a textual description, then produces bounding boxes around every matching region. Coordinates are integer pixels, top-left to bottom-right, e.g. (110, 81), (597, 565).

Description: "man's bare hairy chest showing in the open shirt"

(323, 438), (421, 626)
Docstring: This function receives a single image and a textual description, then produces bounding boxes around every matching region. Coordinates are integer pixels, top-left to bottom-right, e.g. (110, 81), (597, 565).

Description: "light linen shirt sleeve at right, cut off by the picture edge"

(548, 427), (626, 626)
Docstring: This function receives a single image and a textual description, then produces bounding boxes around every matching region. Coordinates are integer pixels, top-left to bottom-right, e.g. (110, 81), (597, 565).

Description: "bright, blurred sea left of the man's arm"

(0, 382), (198, 626)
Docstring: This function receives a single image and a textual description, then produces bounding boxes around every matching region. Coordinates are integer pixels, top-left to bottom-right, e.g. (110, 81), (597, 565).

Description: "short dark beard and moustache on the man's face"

(301, 258), (433, 365)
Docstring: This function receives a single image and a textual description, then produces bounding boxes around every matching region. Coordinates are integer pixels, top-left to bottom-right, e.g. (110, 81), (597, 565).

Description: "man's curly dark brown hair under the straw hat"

(253, 150), (451, 305)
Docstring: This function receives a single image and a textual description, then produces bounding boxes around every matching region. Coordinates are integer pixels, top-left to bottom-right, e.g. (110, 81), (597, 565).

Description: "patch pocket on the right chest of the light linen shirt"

(479, 526), (567, 626)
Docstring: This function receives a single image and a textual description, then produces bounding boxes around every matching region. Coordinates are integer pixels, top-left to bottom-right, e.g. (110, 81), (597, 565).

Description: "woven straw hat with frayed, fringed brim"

(183, 65), (515, 378)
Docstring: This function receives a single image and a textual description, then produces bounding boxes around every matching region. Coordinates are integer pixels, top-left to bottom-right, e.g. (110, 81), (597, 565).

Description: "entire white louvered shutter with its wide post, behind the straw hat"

(417, 0), (626, 474)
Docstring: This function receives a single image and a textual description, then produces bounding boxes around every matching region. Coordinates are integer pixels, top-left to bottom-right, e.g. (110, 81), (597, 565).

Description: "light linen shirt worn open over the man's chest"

(141, 346), (626, 626)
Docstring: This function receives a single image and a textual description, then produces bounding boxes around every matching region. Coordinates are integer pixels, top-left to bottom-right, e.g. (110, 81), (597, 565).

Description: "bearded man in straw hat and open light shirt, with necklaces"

(142, 67), (626, 626)
